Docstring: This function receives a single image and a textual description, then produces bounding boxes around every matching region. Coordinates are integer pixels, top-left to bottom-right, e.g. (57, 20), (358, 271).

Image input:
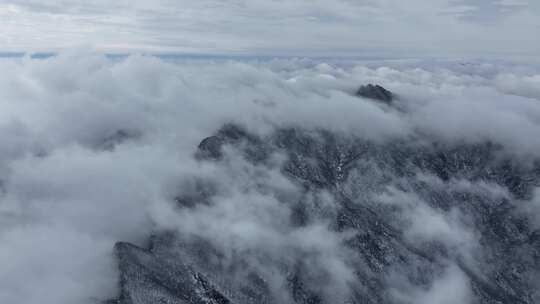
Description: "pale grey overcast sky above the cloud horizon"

(0, 0), (540, 57)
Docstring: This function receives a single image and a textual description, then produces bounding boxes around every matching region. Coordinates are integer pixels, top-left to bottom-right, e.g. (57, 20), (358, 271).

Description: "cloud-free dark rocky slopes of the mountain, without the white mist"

(109, 123), (540, 304)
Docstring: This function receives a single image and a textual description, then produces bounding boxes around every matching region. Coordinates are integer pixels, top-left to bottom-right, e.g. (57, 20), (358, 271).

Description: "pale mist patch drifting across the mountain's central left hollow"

(150, 150), (355, 303)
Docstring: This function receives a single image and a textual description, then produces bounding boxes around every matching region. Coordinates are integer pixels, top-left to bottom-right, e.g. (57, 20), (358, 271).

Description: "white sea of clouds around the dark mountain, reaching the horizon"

(0, 52), (540, 304)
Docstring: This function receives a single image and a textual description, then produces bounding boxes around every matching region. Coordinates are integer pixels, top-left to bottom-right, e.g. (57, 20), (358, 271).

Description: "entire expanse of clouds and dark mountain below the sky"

(0, 51), (540, 304)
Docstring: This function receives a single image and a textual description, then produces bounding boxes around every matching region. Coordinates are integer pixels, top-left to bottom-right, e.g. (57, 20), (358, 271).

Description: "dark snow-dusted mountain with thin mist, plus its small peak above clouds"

(110, 85), (540, 304)
